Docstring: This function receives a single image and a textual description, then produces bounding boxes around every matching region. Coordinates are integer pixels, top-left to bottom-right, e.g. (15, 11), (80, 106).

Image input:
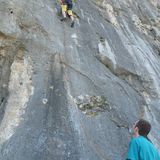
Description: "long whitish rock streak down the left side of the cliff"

(0, 56), (34, 143)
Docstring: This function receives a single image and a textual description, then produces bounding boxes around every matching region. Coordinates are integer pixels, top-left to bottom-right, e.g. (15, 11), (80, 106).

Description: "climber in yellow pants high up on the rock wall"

(60, 0), (74, 27)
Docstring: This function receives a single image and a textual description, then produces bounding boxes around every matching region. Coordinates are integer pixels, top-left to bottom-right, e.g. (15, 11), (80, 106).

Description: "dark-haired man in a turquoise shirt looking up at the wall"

(126, 119), (160, 160)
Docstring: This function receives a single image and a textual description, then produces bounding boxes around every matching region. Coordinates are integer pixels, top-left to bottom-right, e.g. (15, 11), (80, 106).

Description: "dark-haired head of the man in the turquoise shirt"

(133, 119), (151, 138)
